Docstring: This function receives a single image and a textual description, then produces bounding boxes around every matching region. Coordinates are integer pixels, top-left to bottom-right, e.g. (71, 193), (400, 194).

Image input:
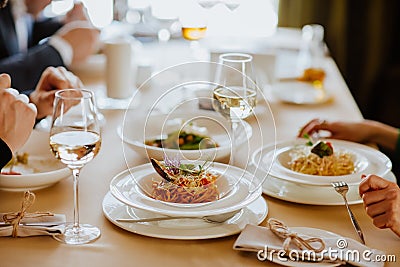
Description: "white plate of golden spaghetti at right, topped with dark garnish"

(252, 139), (392, 186)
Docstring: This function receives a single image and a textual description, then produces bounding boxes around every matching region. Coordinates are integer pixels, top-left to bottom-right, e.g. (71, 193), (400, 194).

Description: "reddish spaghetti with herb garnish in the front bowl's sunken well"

(137, 159), (236, 207)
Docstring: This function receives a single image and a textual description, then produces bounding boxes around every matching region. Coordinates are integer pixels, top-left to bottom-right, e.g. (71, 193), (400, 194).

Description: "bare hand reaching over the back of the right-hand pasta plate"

(297, 119), (371, 143)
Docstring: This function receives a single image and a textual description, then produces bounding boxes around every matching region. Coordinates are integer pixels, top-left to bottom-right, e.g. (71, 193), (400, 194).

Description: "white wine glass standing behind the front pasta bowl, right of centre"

(213, 53), (257, 165)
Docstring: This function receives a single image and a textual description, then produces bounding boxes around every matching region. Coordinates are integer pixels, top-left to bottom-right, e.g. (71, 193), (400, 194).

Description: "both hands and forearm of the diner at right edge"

(297, 119), (400, 237)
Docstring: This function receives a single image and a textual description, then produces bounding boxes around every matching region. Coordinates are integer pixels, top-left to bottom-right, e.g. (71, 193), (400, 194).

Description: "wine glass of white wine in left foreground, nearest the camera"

(50, 89), (101, 245)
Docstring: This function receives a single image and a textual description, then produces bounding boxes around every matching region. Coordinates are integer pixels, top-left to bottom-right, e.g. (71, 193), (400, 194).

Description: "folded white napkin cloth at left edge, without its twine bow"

(0, 213), (66, 237)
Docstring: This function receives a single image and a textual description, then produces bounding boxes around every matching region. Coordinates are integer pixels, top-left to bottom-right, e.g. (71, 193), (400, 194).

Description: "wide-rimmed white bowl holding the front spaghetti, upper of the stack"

(110, 161), (262, 217)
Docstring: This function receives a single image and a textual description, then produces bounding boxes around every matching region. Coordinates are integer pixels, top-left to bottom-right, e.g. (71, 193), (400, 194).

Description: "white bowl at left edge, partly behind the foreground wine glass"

(0, 130), (71, 191)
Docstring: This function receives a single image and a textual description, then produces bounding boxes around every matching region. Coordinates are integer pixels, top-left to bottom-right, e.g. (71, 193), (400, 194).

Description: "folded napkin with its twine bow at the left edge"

(0, 191), (65, 237)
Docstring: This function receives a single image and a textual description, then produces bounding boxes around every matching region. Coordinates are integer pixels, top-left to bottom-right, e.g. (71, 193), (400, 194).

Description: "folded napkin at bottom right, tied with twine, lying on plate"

(233, 224), (384, 267)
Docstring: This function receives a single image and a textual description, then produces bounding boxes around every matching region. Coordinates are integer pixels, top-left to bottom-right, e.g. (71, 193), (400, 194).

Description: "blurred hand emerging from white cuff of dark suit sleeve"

(56, 21), (100, 64)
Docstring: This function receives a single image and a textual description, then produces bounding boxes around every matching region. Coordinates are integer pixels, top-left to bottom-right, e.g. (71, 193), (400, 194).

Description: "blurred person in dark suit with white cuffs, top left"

(0, 0), (99, 91)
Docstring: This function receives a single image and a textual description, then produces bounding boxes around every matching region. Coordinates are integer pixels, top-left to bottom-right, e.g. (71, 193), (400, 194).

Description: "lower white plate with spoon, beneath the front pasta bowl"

(103, 192), (268, 240)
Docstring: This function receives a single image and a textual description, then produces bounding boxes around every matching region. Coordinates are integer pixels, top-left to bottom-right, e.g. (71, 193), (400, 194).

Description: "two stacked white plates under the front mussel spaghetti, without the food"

(103, 163), (268, 239)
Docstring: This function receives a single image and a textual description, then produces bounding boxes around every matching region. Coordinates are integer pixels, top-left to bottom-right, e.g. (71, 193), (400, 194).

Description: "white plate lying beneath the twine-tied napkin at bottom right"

(267, 227), (341, 267)
